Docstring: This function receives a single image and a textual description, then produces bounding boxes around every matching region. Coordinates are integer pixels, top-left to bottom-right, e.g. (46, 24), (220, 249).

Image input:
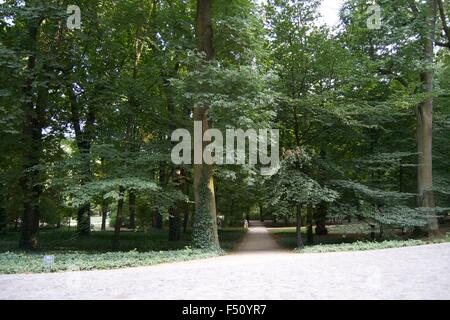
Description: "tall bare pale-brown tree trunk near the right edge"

(417, 0), (439, 233)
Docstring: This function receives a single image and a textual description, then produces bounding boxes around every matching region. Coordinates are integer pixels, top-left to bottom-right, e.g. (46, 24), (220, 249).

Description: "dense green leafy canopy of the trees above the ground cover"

(0, 0), (450, 254)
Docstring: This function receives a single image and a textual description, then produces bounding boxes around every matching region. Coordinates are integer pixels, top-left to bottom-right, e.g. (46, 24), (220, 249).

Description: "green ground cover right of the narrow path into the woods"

(269, 224), (450, 253)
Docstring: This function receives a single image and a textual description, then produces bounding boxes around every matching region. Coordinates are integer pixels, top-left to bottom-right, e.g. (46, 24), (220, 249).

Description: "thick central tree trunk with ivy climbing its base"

(192, 0), (220, 249)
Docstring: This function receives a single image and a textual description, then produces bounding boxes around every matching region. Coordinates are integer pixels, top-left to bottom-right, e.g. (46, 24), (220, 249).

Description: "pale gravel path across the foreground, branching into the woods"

(0, 225), (450, 300)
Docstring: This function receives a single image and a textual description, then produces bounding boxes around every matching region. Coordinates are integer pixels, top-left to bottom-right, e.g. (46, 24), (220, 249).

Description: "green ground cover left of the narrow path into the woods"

(0, 228), (246, 274)
